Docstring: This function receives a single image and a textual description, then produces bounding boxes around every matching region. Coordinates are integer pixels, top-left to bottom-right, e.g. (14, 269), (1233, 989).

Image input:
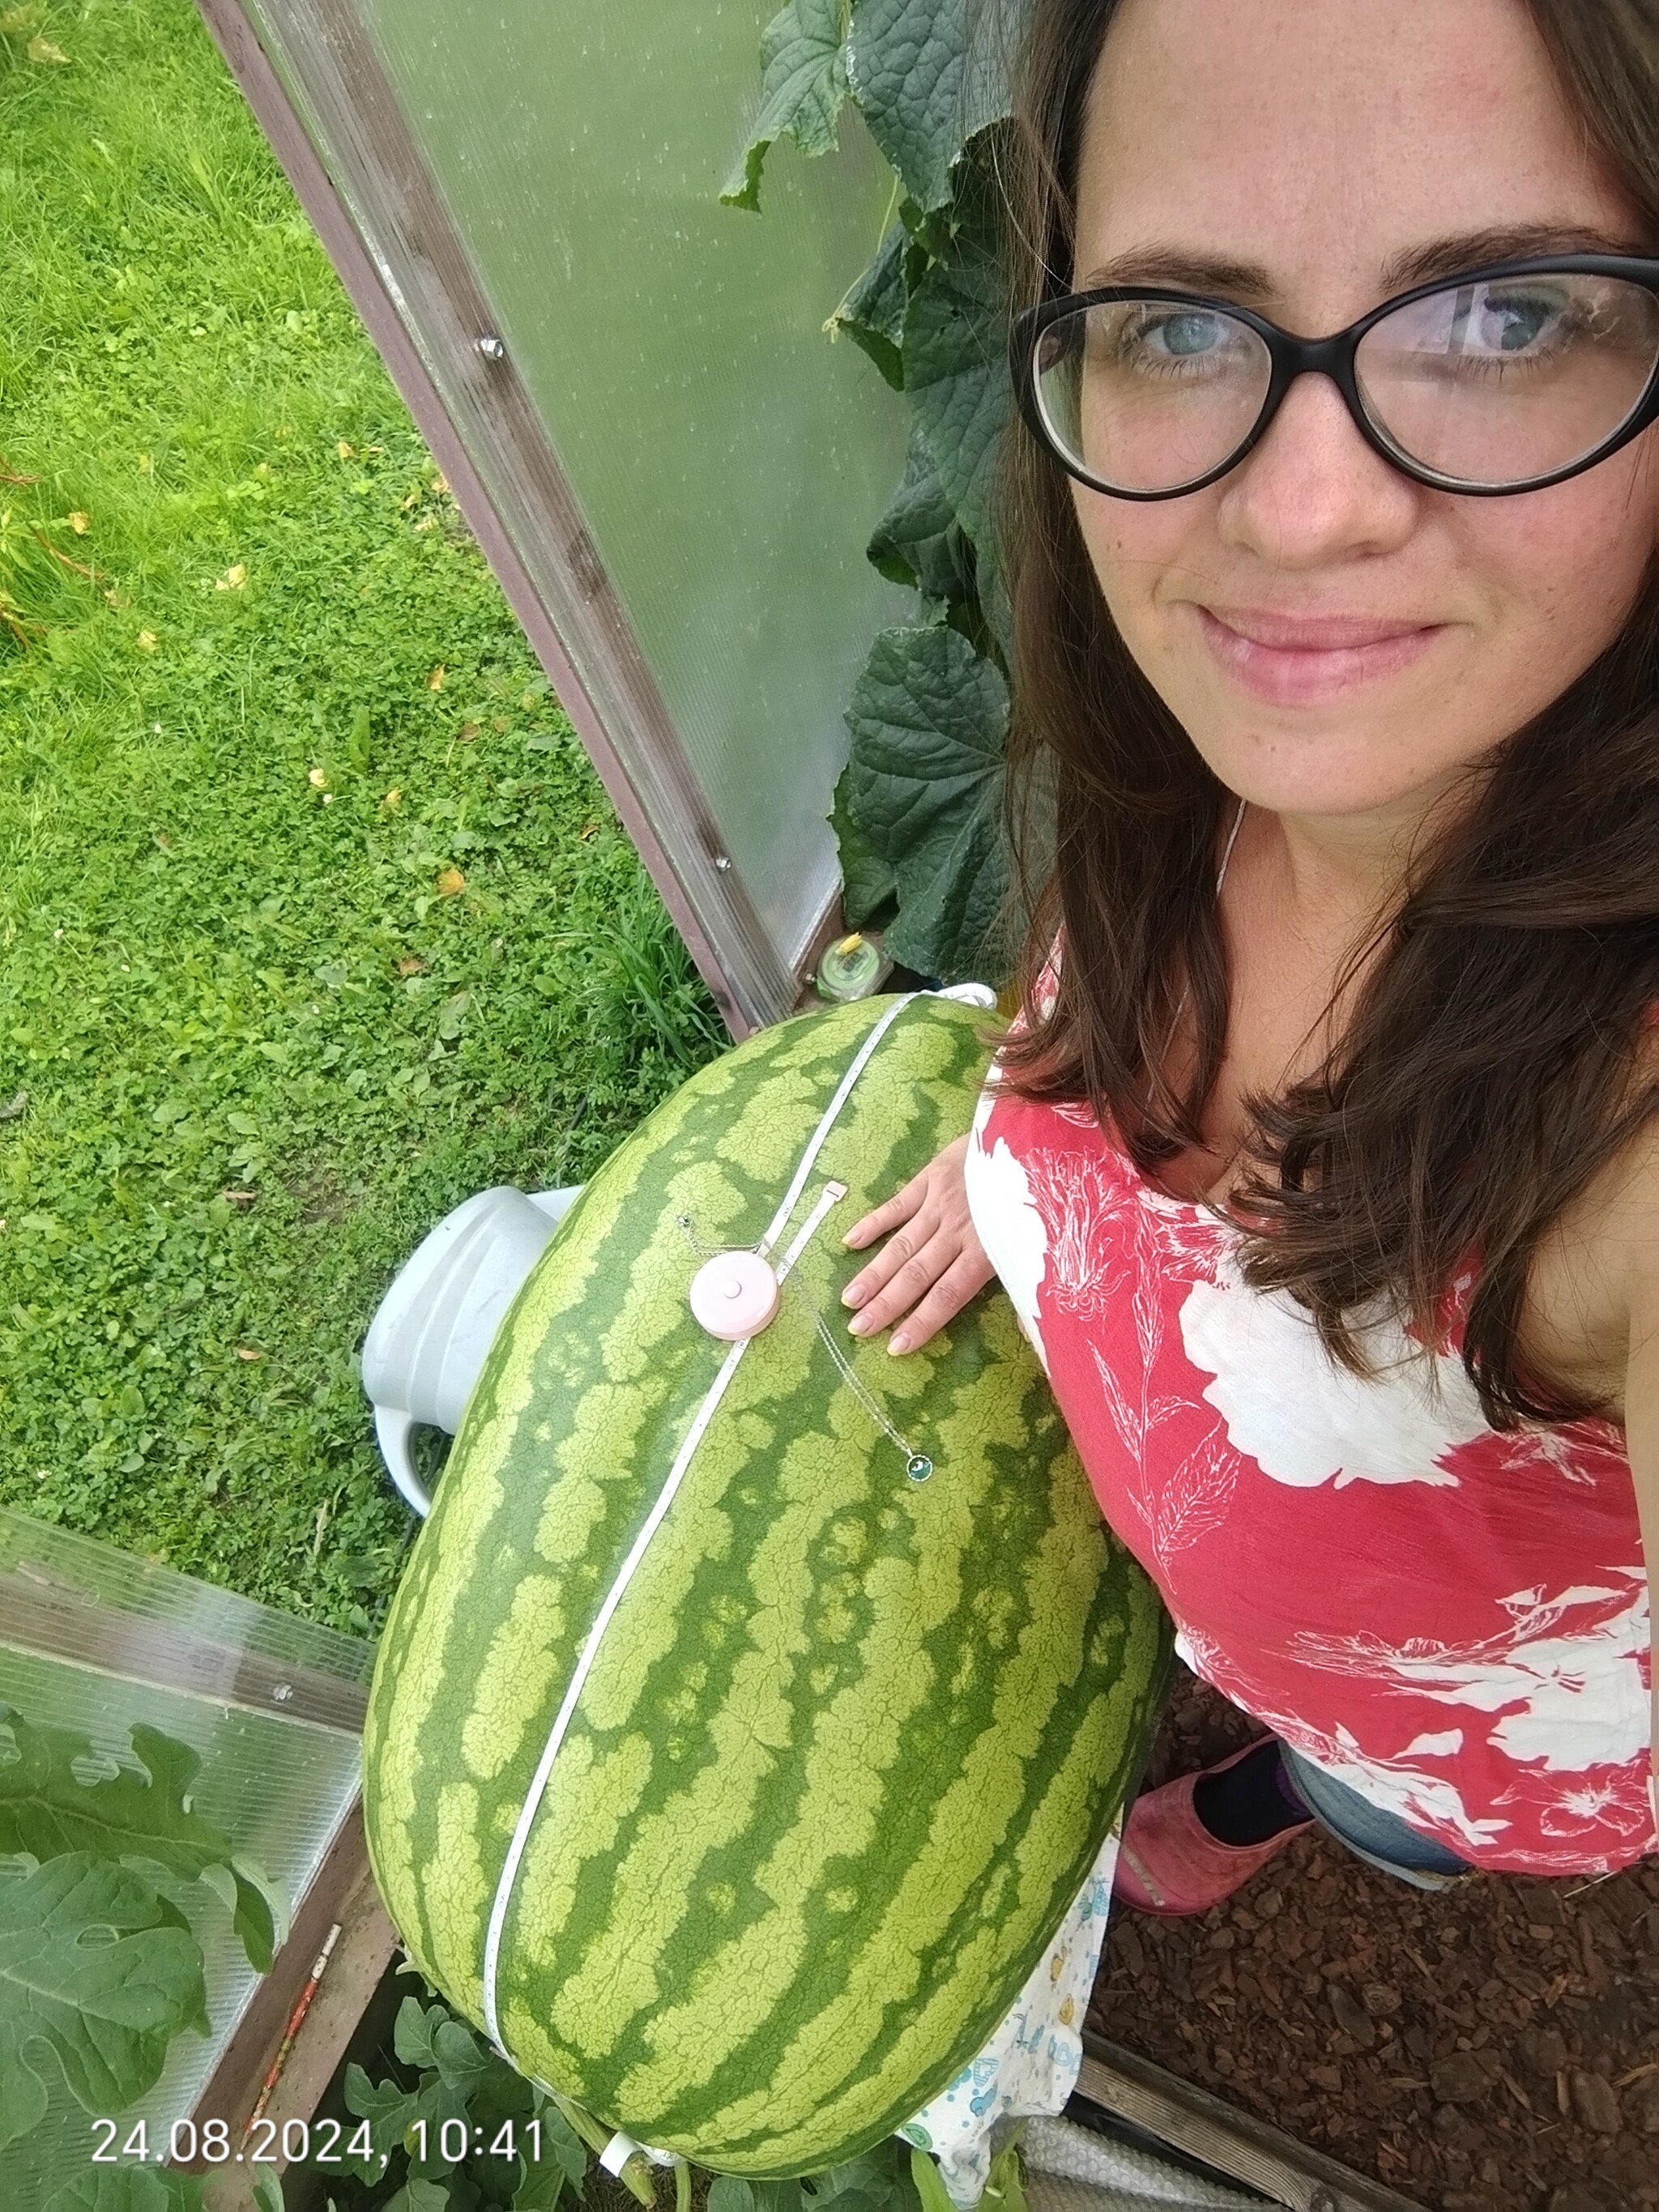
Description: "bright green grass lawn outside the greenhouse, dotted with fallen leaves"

(0, 0), (717, 1630)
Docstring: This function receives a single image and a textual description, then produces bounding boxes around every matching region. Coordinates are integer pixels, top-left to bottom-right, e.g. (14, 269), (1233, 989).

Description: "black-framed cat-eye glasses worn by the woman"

(1011, 254), (1659, 500)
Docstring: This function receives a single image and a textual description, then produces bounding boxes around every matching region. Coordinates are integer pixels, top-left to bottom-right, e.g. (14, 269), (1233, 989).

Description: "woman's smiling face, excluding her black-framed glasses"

(1073, 0), (1659, 820)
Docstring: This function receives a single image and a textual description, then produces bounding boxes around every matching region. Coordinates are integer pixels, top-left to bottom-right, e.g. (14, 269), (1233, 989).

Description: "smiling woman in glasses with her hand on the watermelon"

(847, 0), (1659, 1913)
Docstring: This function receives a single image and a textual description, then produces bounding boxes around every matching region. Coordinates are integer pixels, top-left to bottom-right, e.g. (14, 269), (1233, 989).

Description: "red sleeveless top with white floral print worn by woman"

(966, 987), (1659, 1873)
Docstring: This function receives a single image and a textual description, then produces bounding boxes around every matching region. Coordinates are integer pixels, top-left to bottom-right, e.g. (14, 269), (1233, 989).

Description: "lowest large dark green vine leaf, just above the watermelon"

(842, 624), (1009, 982)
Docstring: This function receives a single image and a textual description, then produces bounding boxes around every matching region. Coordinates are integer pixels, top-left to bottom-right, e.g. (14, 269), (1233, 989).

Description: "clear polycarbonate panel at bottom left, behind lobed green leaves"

(0, 1511), (373, 2208)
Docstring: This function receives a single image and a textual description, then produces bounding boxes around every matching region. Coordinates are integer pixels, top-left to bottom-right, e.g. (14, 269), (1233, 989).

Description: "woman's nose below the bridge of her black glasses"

(1219, 374), (1422, 571)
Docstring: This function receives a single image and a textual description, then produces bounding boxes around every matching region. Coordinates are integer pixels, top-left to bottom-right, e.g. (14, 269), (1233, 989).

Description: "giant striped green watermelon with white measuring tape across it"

(363, 995), (1168, 2179)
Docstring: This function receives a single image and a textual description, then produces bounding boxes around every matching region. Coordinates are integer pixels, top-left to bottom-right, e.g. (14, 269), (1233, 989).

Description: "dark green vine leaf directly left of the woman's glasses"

(905, 243), (1013, 547)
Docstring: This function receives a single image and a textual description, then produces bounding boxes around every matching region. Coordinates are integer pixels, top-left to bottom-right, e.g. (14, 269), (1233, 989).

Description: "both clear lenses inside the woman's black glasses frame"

(1035, 272), (1659, 493)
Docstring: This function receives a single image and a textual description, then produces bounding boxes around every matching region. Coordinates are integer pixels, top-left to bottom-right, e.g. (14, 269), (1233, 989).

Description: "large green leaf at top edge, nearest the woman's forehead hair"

(847, 0), (1009, 210)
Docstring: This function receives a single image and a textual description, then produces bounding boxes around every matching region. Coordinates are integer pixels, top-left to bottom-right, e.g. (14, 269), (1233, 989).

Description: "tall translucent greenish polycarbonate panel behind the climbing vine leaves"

(334, 0), (905, 960)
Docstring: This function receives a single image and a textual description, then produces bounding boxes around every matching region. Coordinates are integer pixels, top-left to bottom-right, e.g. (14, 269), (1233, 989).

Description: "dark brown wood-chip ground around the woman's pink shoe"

(1088, 1674), (1659, 2212)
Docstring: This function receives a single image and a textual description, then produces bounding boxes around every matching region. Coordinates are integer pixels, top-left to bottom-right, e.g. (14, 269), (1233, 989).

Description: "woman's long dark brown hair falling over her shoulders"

(1002, 0), (1659, 1426)
